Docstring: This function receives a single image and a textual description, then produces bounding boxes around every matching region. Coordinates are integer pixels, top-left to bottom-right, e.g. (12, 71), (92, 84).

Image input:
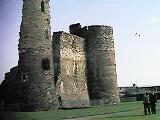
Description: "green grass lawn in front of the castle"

(0, 102), (160, 120)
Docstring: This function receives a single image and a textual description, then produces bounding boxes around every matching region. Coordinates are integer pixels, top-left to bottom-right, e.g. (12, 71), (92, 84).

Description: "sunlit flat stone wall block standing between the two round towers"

(53, 32), (89, 108)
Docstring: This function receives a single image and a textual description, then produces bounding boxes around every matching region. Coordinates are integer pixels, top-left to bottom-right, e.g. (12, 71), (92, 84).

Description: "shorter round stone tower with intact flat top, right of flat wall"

(83, 25), (120, 104)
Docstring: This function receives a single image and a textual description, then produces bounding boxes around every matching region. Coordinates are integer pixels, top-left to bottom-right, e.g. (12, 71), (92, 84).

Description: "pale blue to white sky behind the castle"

(0, 0), (160, 86)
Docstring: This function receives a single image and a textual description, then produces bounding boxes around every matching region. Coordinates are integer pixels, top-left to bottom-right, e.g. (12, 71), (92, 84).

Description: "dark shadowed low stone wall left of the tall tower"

(0, 66), (21, 111)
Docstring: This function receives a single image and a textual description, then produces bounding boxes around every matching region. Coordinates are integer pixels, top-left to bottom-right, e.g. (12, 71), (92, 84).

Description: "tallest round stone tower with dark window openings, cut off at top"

(18, 0), (56, 111)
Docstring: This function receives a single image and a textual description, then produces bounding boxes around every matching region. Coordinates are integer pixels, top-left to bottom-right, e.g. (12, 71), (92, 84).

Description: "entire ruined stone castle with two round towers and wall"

(0, 0), (120, 111)
